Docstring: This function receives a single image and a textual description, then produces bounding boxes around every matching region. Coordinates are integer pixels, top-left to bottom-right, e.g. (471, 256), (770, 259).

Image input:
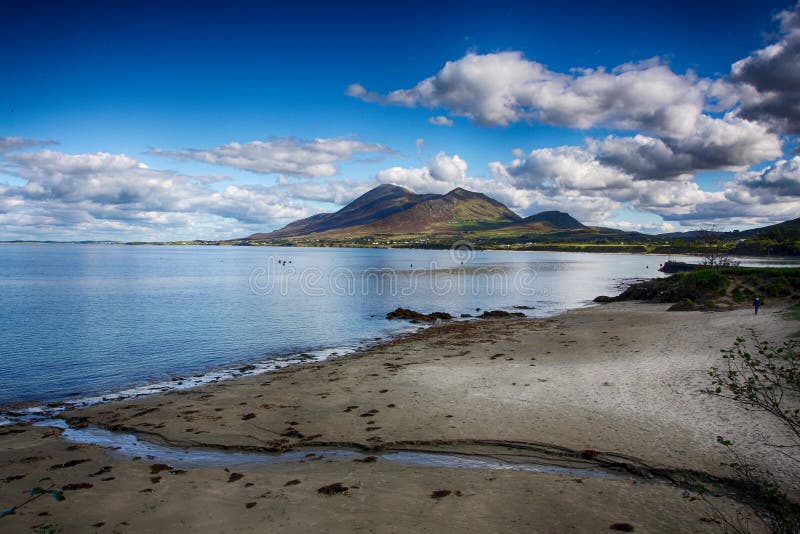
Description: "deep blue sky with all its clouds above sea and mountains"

(0, 1), (800, 239)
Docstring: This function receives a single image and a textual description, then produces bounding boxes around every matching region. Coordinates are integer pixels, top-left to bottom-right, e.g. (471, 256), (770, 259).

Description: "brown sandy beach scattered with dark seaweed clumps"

(0, 303), (800, 532)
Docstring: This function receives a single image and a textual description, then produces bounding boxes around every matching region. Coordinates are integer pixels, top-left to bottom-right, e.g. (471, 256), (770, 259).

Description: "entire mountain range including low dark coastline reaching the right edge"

(230, 185), (800, 256)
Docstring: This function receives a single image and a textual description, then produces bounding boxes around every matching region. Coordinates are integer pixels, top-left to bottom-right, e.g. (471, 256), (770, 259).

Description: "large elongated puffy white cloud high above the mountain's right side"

(347, 51), (705, 137)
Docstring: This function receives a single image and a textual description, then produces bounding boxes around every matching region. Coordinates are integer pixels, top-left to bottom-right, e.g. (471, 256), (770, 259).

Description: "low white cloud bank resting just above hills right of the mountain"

(490, 147), (800, 231)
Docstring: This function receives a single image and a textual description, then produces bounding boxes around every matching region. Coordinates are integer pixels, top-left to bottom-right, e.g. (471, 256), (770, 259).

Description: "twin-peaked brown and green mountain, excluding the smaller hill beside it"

(249, 185), (520, 240)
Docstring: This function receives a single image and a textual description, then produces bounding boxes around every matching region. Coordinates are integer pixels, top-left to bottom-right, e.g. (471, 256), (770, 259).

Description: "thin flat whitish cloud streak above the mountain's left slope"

(151, 137), (395, 178)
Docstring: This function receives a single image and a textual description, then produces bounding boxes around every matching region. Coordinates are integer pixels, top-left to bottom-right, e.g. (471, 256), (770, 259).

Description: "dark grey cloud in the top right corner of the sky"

(730, 3), (800, 134)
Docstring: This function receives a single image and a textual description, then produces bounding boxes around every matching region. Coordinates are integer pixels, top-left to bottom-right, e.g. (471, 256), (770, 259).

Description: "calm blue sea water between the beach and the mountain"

(0, 244), (792, 405)
